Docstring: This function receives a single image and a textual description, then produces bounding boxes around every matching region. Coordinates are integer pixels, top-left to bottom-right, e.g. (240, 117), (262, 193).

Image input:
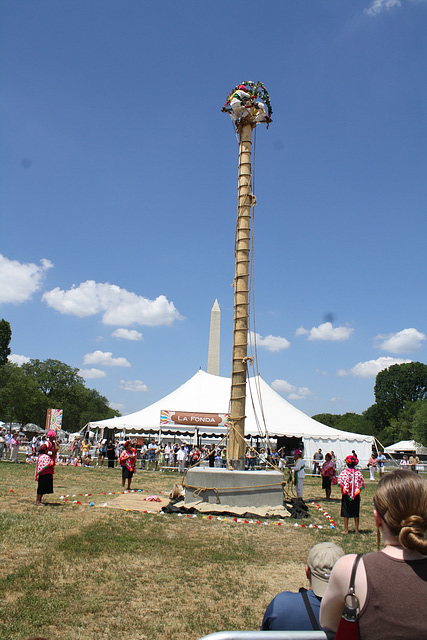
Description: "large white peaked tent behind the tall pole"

(89, 369), (374, 465)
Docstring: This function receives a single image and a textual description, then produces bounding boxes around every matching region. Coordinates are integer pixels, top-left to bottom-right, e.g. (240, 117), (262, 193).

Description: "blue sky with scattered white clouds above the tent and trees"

(0, 0), (427, 415)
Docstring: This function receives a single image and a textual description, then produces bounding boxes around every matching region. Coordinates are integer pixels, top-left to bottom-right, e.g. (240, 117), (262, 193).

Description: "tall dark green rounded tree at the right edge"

(374, 362), (427, 423)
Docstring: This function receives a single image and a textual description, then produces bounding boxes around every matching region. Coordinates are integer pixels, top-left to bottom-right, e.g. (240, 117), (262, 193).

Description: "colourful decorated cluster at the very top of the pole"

(222, 80), (273, 128)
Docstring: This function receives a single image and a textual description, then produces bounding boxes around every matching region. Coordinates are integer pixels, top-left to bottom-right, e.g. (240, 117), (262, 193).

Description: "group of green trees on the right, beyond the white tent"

(312, 362), (427, 446)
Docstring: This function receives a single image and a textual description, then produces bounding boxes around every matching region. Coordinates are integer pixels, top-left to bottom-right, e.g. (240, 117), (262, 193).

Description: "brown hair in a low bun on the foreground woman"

(374, 469), (427, 554)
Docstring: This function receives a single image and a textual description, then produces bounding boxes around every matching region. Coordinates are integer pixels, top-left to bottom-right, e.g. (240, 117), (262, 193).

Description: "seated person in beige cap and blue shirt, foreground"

(261, 542), (344, 631)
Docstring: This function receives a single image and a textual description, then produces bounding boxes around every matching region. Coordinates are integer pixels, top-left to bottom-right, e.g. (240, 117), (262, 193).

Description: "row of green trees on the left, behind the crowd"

(0, 319), (120, 433)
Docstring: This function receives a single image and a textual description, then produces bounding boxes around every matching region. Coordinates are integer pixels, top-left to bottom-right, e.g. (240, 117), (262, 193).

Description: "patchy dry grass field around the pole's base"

(0, 462), (382, 640)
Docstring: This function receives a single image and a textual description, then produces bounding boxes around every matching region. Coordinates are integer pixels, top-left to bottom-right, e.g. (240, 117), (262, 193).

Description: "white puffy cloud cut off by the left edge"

(0, 254), (53, 304)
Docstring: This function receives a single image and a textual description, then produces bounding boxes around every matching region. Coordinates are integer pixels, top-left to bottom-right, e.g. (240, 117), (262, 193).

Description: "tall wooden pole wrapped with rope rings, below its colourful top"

(227, 122), (255, 469)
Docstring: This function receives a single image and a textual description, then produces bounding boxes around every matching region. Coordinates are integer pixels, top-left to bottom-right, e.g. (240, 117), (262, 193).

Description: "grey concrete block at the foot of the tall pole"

(185, 467), (283, 507)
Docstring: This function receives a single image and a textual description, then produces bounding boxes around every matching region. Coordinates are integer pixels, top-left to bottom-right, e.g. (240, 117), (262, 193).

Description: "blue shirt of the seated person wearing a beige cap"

(261, 589), (322, 631)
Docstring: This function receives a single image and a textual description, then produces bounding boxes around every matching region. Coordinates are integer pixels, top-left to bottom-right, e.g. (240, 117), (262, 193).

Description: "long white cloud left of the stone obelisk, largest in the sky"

(42, 280), (181, 327)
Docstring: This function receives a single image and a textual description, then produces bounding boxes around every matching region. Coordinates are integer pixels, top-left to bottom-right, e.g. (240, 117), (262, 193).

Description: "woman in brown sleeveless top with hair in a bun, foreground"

(320, 469), (427, 640)
